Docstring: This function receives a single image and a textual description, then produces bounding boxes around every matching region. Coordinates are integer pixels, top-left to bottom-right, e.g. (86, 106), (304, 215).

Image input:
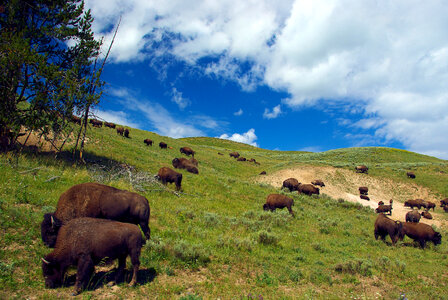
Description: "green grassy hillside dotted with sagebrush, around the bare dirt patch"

(0, 127), (448, 299)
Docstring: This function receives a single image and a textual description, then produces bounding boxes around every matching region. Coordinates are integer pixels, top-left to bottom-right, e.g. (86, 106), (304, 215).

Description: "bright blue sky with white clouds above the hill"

(86, 0), (448, 159)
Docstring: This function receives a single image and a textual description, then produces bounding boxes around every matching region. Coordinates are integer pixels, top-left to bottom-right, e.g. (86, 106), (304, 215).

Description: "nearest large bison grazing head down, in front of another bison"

(42, 218), (143, 295)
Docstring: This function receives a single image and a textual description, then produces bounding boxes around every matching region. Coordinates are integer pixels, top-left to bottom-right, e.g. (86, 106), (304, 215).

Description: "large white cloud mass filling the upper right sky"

(86, 0), (448, 158)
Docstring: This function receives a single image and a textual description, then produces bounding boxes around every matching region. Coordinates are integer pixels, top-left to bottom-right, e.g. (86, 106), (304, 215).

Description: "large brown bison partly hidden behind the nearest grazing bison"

(41, 182), (150, 248)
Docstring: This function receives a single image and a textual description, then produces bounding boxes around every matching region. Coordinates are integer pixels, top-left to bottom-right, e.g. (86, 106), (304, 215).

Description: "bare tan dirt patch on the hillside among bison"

(257, 166), (448, 227)
